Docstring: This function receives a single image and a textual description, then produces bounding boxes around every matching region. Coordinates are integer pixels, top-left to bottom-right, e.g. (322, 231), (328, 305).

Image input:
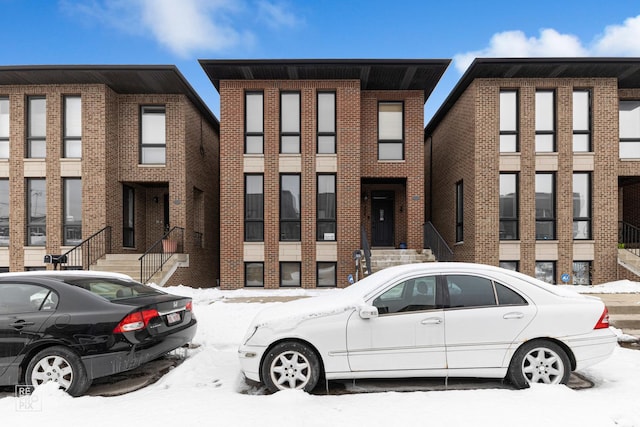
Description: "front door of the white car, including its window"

(347, 276), (446, 371)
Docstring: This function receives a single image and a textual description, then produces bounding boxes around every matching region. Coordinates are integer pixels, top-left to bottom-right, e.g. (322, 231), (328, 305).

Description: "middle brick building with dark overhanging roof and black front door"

(200, 60), (449, 289)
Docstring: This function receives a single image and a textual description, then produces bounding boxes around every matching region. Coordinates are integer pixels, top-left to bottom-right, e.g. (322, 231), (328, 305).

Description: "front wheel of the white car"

(261, 342), (320, 392)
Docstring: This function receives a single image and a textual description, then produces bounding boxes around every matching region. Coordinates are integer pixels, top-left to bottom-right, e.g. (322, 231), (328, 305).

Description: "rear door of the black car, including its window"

(0, 282), (58, 378)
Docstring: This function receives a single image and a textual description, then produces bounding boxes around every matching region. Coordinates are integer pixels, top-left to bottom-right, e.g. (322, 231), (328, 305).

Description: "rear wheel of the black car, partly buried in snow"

(25, 346), (91, 396)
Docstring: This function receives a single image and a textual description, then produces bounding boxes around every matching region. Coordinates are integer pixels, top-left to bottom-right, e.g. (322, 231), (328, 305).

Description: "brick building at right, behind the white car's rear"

(425, 58), (640, 284)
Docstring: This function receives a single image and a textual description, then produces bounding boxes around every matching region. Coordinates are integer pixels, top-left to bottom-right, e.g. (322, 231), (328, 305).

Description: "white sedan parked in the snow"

(238, 263), (617, 391)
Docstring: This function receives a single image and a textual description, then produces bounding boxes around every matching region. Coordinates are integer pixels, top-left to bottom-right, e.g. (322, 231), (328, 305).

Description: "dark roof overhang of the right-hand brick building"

(425, 58), (640, 136)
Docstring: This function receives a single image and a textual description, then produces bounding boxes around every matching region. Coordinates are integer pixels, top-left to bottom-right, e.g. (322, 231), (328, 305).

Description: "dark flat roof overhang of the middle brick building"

(200, 59), (451, 101)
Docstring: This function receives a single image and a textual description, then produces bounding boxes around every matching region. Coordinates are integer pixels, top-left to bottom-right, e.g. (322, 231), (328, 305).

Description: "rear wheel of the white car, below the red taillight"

(508, 341), (571, 388)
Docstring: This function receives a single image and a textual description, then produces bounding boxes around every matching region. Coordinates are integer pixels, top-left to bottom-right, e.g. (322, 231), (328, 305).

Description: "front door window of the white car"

(373, 276), (437, 315)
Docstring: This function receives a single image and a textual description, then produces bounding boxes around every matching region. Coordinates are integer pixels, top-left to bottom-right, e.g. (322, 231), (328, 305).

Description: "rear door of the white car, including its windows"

(443, 275), (536, 369)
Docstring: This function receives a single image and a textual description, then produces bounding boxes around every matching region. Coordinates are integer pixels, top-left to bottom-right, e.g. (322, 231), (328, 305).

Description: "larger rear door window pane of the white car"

(447, 275), (496, 308)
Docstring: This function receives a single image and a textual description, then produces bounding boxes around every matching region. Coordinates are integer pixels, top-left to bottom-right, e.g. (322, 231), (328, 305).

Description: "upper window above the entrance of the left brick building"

(140, 105), (167, 165)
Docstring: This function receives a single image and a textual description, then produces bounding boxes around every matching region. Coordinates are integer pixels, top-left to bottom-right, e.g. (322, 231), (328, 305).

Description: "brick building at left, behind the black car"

(0, 66), (219, 286)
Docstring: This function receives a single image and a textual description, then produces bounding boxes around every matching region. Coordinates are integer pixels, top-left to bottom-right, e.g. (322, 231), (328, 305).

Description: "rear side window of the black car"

(0, 283), (58, 314)
